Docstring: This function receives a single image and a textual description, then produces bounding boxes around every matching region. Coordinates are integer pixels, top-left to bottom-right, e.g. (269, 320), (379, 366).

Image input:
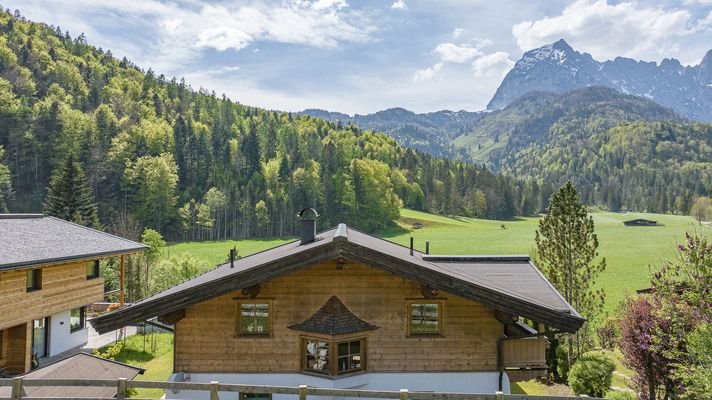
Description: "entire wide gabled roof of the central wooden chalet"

(91, 224), (585, 333)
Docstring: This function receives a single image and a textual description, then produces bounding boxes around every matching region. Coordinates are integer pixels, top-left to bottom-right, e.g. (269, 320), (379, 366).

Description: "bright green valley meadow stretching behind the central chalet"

(165, 210), (712, 313)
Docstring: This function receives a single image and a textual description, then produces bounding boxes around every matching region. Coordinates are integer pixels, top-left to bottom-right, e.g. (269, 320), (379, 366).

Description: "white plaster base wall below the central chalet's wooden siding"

(166, 372), (510, 400)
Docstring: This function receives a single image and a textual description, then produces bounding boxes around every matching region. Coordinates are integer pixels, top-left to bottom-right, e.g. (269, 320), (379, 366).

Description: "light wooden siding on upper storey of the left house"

(0, 261), (104, 329)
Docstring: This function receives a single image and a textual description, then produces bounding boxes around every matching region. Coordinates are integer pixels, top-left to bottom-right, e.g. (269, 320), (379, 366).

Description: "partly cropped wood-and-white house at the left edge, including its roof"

(0, 214), (147, 374)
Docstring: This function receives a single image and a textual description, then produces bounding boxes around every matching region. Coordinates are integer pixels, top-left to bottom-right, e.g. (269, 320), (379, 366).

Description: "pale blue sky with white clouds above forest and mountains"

(3, 0), (712, 114)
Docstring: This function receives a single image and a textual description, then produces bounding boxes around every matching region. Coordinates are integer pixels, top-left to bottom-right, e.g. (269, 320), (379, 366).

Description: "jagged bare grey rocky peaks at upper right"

(487, 39), (712, 122)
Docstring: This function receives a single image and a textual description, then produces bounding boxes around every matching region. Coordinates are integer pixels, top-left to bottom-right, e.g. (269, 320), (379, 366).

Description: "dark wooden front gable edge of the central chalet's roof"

(90, 228), (585, 333)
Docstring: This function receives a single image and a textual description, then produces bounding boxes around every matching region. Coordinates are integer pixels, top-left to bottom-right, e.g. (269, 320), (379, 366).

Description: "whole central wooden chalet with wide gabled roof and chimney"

(91, 210), (584, 400)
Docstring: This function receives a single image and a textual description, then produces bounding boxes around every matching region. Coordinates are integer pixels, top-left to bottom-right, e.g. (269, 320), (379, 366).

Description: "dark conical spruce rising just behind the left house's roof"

(45, 153), (99, 228)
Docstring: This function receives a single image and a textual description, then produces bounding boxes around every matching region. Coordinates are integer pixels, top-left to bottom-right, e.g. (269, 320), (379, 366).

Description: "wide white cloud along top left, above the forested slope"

(11, 0), (377, 73)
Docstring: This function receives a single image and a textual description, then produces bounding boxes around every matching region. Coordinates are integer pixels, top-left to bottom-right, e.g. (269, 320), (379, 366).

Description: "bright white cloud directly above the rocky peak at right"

(512, 0), (696, 62)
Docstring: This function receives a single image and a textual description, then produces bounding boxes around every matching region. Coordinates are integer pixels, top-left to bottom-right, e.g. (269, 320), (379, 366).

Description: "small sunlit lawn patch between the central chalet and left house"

(99, 333), (173, 399)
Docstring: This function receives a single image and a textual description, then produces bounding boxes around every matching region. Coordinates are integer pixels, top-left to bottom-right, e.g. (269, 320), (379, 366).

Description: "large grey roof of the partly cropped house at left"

(0, 214), (148, 270)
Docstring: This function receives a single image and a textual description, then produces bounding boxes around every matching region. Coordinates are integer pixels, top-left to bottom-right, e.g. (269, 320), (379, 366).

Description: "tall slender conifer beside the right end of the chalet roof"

(535, 182), (606, 366)
